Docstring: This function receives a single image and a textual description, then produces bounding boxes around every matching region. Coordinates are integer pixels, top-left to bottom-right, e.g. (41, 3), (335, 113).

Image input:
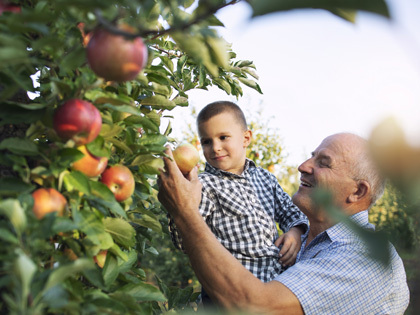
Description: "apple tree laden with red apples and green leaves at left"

(0, 0), (394, 314)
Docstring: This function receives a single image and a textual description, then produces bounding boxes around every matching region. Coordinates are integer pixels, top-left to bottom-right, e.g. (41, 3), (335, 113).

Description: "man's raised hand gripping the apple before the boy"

(158, 147), (201, 223)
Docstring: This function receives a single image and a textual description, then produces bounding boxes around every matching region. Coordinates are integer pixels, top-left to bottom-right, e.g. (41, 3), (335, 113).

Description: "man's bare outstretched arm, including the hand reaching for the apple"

(158, 149), (303, 314)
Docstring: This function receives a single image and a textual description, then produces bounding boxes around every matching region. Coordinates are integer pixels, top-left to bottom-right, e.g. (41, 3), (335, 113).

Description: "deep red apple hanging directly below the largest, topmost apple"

(53, 99), (102, 145)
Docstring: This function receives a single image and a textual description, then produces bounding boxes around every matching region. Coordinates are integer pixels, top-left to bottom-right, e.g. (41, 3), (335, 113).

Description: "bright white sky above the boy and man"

(167, 0), (420, 165)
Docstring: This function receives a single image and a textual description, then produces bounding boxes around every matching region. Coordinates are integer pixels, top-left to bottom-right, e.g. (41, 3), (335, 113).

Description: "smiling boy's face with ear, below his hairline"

(198, 112), (252, 175)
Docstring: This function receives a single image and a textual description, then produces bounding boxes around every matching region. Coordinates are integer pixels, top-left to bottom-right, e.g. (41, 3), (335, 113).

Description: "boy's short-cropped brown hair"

(197, 101), (248, 130)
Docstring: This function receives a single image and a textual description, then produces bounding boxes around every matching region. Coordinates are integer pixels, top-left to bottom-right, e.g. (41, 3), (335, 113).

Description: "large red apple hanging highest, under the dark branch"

(86, 26), (147, 82)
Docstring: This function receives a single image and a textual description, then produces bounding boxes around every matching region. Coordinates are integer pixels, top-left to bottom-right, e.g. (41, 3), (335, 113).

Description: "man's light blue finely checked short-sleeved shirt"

(275, 211), (409, 315)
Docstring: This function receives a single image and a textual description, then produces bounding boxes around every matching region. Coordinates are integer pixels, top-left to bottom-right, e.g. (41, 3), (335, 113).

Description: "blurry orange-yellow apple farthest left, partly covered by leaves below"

(32, 188), (67, 219)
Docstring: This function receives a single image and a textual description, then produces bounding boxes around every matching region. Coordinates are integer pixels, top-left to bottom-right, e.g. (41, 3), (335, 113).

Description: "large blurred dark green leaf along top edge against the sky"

(247, 0), (390, 18)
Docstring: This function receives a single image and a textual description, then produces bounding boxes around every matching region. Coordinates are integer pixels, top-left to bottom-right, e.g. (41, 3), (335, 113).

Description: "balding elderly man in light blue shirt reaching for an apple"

(159, 133), (409, 314)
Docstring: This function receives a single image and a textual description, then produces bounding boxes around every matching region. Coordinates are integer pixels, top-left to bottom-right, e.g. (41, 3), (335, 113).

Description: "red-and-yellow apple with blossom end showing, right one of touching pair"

(100, 164), (135, 201)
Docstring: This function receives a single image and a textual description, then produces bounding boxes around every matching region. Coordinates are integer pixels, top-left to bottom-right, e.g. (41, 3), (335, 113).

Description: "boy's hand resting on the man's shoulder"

(274, 227), (302, 267)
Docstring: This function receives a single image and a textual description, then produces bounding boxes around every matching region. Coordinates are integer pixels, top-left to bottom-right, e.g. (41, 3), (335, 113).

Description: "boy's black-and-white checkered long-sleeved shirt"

(169, 159), (308, 282)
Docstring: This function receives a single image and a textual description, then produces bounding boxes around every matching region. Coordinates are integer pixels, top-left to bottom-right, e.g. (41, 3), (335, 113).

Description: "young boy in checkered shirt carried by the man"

(169, 101), (308, 304)
